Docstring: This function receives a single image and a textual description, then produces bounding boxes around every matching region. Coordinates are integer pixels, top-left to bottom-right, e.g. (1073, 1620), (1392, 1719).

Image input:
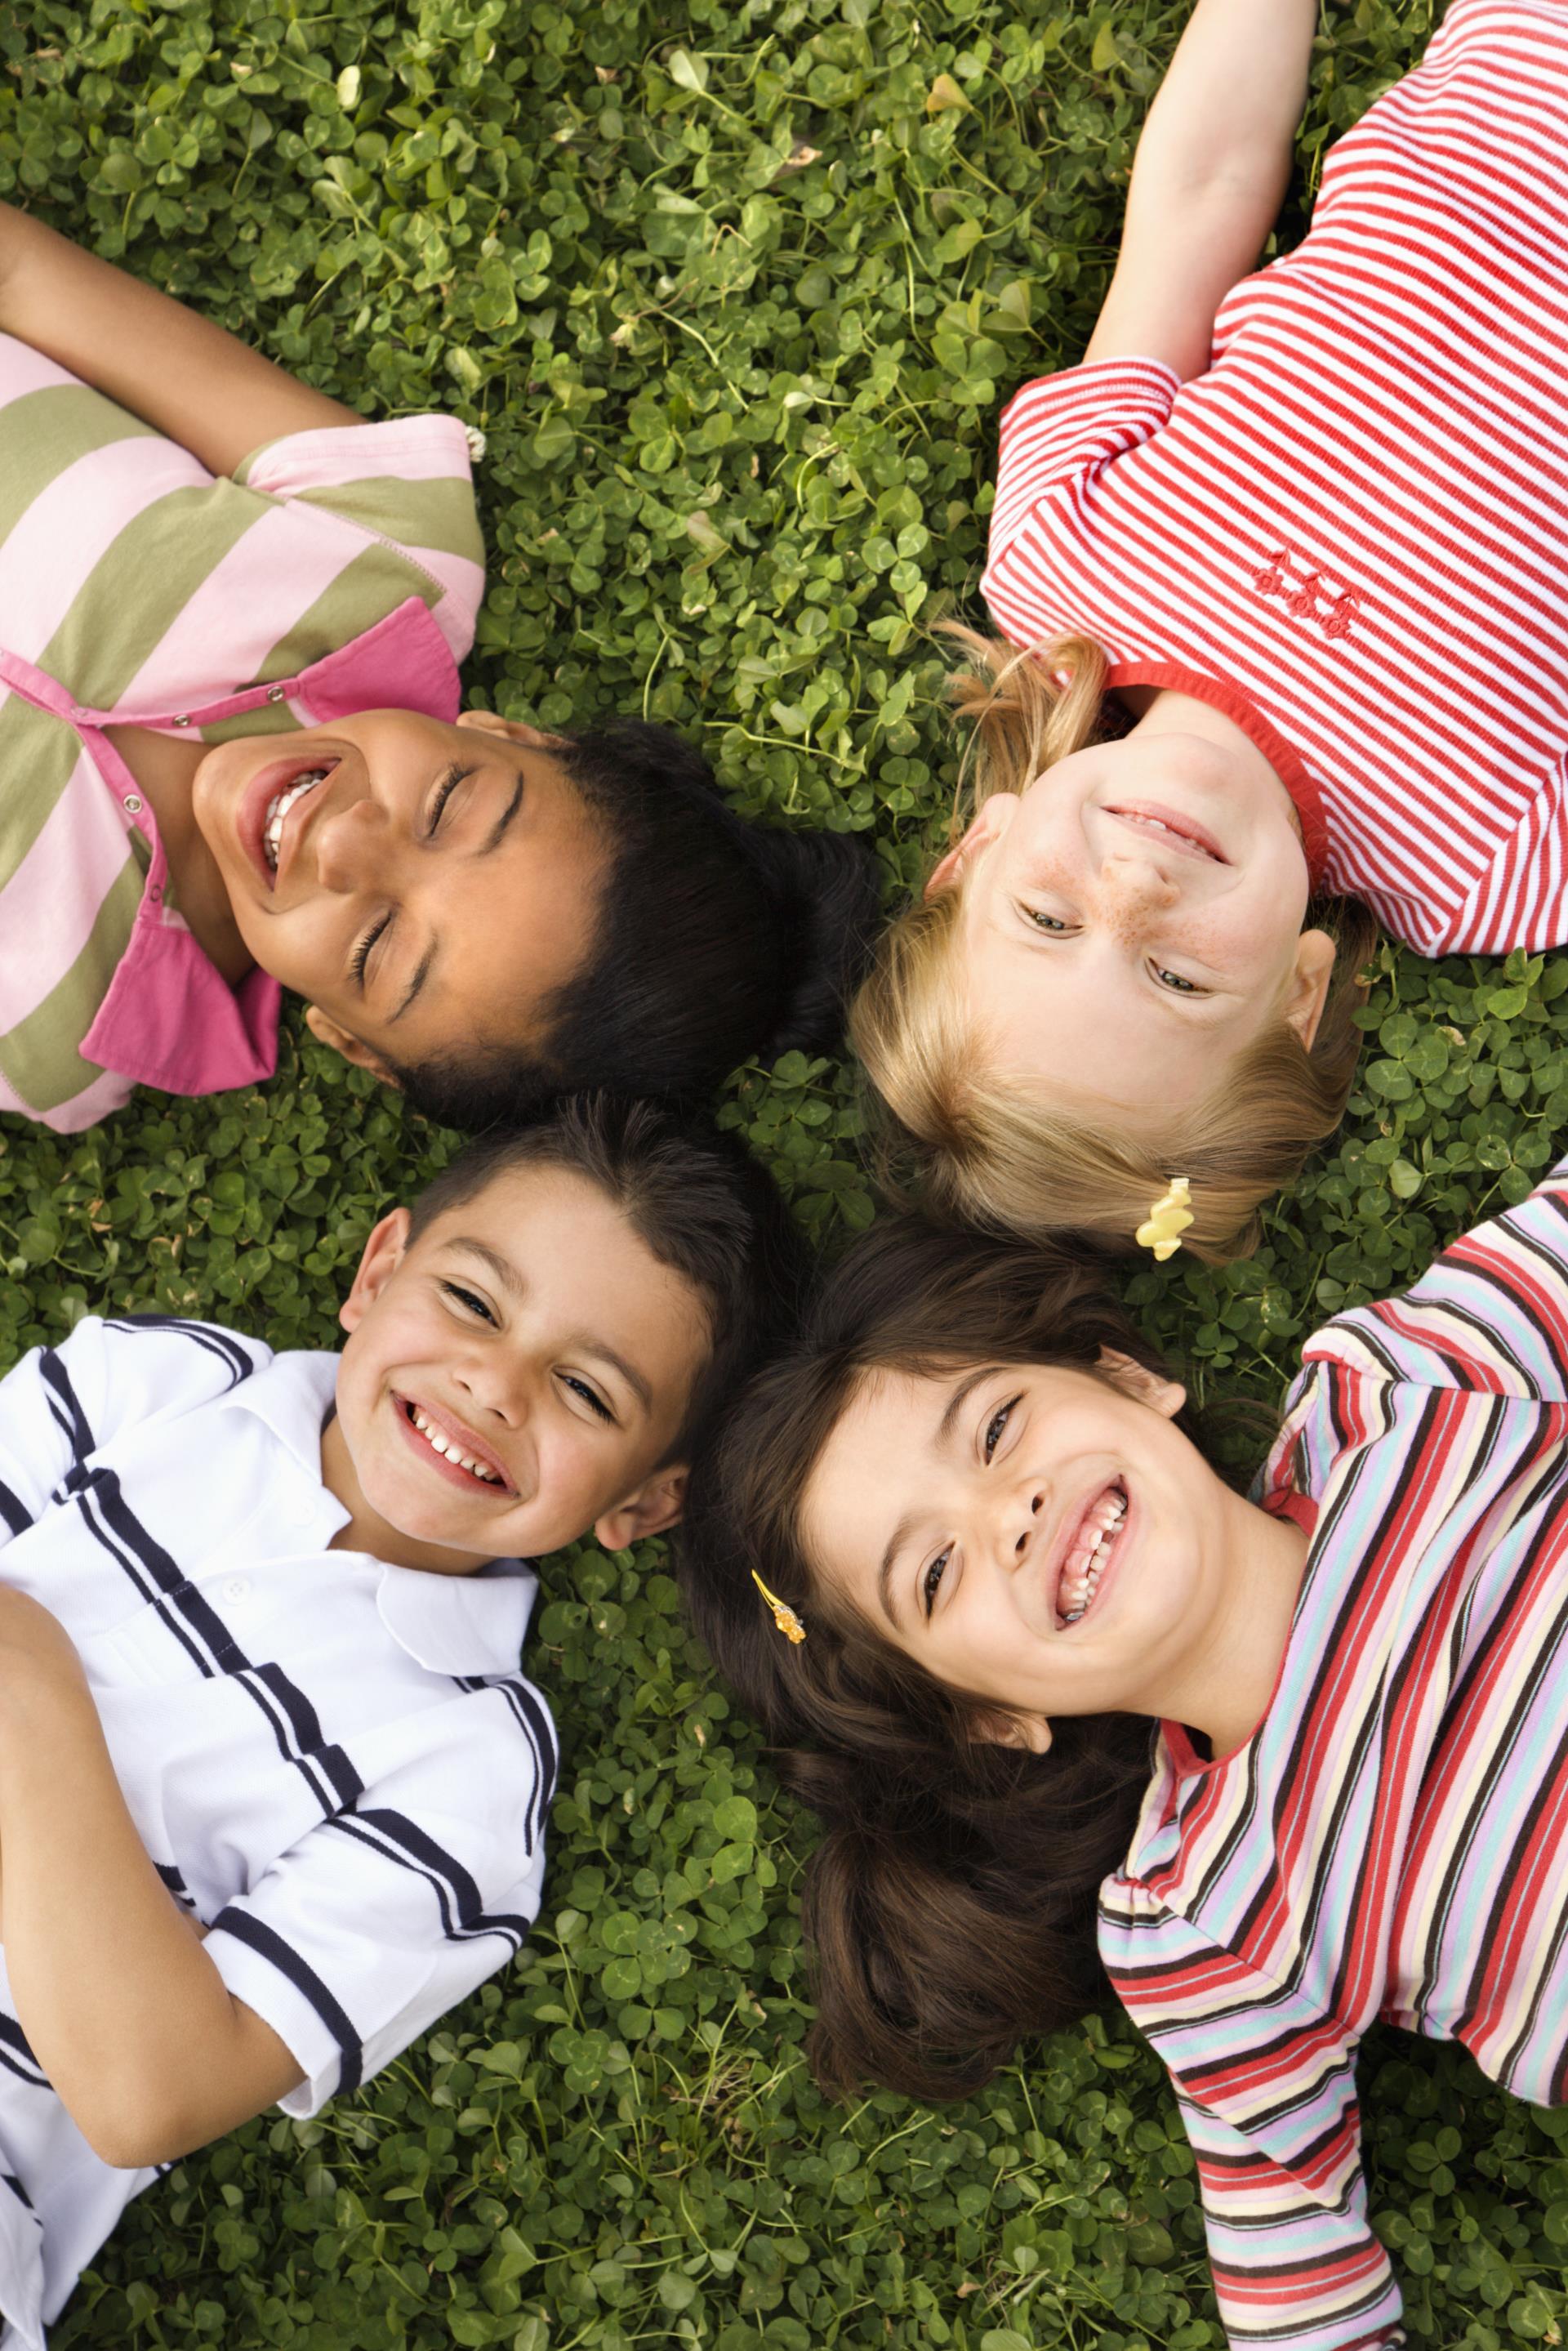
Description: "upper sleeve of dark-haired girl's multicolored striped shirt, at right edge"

(1303, 1162), (1568, 1403)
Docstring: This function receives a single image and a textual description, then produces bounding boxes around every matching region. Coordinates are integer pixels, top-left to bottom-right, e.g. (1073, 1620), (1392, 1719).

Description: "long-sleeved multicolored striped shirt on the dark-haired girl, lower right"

(1100, 1162), (1568, 2351)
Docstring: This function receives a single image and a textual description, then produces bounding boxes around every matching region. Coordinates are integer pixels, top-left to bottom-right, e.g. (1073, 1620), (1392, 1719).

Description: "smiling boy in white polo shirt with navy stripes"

(0, 1098), (795, 2351)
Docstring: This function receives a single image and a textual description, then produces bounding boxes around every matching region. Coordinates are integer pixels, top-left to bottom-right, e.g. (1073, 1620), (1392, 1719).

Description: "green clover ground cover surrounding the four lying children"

(0, 0), (1568, 2351)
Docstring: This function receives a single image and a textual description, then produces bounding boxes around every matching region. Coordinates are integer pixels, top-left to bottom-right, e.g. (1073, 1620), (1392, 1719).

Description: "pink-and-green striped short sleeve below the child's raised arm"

(233, 416), (484, 661)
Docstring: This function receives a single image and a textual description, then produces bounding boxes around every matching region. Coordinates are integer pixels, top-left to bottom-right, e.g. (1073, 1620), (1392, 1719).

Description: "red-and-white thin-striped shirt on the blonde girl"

(985, 0), (1568, 954)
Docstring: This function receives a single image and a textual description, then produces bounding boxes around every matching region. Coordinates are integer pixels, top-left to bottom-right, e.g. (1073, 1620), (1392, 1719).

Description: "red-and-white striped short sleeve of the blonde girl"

(985, 359), (1180, 576)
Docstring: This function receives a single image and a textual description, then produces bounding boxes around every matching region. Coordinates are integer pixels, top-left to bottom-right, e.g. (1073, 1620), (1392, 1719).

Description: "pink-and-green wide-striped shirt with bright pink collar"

(0, 337), (484, 1133)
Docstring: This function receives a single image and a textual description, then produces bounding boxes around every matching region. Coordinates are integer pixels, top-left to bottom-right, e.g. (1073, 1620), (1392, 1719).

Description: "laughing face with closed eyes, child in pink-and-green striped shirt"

(193, 710), (607, 1072)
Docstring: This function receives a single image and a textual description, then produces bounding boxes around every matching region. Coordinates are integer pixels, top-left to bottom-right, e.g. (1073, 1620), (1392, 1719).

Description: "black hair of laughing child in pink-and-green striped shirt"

(393, 720), (877, 1131)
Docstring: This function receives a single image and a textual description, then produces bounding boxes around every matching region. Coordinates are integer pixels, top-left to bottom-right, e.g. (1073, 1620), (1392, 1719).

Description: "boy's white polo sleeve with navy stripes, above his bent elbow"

(207, 1756), (543, 2116)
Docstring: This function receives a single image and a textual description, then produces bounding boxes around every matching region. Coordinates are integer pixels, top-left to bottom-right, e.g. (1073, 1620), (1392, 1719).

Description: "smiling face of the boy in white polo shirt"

(322, 1166), (710, 1573)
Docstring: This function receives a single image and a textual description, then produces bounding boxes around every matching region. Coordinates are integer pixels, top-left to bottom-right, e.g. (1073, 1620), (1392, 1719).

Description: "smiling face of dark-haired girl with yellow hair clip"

(802, 1357), (1260, 1724)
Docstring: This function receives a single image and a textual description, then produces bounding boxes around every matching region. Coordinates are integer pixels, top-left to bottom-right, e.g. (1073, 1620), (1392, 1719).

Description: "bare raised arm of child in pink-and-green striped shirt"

(0, 204), (362, 472)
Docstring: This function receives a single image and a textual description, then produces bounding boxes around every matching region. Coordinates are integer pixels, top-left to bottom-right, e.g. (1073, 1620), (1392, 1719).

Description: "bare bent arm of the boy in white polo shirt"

(0, 1650), (299, 2166)
